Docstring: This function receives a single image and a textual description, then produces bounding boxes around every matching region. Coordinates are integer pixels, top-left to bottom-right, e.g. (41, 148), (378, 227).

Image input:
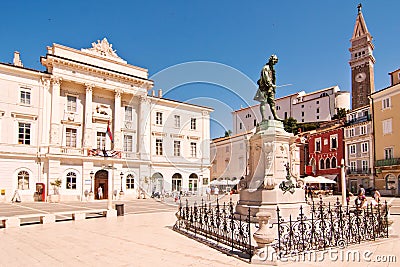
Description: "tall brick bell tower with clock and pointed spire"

(349, 4), (375, 109)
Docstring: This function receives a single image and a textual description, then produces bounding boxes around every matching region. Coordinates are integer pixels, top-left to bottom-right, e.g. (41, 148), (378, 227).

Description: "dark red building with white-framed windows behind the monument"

(306, 124), (344, 192)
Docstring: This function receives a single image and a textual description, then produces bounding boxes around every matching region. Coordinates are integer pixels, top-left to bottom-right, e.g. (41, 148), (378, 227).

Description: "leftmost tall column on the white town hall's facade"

(50, 77), (64, 146)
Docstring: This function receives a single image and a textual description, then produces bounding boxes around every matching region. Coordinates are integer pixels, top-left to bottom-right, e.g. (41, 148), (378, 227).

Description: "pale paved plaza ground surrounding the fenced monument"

(0, 197), (400, 267)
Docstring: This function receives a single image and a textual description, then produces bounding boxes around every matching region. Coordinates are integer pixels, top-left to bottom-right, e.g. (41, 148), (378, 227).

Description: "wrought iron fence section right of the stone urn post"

(273, 199), (388, 257)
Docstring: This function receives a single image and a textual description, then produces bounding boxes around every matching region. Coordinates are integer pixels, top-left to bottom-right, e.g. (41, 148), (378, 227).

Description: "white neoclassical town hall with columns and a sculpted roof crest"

(0, 39), (212, 201)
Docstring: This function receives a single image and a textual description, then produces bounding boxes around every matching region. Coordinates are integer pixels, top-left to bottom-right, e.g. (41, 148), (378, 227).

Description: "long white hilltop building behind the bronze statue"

(232, 86), (350, 134)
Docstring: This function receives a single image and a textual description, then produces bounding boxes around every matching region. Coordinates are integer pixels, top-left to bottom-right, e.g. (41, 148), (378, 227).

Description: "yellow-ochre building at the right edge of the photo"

(371, 69), (400, 195)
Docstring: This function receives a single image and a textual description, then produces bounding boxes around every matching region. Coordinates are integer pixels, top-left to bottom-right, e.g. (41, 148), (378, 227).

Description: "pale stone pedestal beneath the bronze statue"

(236, 120), (307, 223)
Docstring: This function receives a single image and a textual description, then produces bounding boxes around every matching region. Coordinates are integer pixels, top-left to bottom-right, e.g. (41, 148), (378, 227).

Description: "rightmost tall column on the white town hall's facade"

(137, 96), (151, 160)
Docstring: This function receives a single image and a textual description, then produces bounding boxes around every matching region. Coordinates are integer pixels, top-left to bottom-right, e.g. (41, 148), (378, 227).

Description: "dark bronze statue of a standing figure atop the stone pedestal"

(254, 55), (282, 121)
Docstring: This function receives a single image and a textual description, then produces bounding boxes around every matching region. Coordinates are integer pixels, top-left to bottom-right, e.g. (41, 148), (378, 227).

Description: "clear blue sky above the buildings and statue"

(0, 0), (400, 137)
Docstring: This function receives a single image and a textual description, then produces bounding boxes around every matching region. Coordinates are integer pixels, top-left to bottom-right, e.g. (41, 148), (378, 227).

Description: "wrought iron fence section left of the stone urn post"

(173, 200), (254, 261)
